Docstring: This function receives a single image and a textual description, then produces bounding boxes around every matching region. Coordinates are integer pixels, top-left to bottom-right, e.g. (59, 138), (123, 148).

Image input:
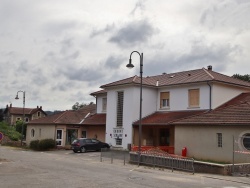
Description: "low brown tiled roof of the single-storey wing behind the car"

(29, 104), (96, 124)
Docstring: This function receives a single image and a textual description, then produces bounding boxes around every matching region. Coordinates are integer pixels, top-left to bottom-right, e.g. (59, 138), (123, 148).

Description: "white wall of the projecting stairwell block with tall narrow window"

(106, 86), (157, 149)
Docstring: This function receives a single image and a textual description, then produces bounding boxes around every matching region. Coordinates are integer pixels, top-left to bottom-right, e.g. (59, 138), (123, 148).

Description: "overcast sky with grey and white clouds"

(0, 0), (250, 110)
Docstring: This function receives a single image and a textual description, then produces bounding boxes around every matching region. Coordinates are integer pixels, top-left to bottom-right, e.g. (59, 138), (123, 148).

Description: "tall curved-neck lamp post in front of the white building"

(126, 51), (143, 166)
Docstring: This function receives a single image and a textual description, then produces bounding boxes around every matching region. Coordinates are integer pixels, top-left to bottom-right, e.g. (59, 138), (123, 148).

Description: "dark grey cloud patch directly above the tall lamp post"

(109, 20), (156, 47)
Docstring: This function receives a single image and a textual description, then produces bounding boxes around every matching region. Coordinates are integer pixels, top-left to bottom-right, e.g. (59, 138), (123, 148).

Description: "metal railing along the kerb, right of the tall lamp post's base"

(130, 148), (194, 174)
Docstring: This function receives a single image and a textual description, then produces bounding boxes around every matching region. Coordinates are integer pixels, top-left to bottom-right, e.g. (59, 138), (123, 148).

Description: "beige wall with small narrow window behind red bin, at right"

(175, 125), (250, 163)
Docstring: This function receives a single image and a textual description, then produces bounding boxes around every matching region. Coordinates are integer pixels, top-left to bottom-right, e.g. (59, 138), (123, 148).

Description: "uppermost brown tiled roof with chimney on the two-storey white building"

(101, 68), (250, 88)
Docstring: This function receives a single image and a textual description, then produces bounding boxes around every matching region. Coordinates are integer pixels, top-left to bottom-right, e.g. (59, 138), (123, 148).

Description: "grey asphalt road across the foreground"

(0, 146), (250, 188)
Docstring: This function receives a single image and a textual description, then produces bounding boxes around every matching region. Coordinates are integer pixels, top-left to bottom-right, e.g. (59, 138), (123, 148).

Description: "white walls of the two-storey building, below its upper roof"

(97, 74), (250, 149)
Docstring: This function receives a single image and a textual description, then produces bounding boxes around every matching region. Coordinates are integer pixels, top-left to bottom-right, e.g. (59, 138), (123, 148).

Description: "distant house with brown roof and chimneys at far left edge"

(3, 104), (47, 125)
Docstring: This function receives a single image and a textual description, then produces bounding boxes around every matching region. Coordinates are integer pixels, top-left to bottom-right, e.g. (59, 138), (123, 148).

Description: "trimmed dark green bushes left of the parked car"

(30, 139), (56, 151)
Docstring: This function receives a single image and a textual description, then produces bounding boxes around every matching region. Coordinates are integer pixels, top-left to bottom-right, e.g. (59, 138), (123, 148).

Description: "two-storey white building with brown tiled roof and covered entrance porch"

(91, 66), (250, 163)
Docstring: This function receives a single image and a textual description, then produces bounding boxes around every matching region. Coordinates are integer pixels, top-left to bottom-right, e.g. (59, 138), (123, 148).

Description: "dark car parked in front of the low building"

(71, 138), (110, 153)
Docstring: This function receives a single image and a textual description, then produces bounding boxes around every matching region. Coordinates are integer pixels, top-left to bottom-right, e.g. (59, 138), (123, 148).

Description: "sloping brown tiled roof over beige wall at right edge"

(174, 93), (250, 125)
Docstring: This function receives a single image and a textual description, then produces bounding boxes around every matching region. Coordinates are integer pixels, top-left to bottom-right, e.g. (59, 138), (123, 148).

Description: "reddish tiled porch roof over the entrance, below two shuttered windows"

(133, 110), (205, 125)
